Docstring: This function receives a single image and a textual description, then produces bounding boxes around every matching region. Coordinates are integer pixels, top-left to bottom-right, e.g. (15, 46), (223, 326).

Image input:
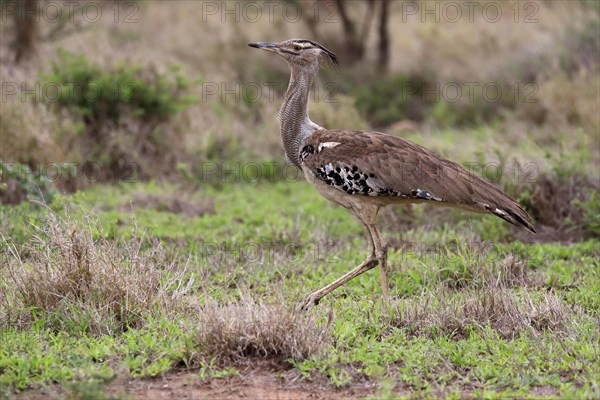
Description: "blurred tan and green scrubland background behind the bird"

(0, 0), (600, 235)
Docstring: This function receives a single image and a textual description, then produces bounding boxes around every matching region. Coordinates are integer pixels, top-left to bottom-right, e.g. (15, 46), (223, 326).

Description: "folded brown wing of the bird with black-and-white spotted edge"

(300, 130), (533, 231)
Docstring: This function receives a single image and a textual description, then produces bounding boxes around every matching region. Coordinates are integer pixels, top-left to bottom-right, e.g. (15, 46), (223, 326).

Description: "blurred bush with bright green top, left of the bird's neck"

(42, 51), (195, 180)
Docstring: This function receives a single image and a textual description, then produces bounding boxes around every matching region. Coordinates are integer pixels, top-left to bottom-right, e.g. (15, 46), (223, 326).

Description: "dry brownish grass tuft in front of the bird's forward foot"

(196, 299), (330, 363)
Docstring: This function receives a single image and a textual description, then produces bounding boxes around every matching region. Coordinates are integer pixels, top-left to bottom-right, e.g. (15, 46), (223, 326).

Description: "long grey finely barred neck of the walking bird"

(279, 68), (318, 168)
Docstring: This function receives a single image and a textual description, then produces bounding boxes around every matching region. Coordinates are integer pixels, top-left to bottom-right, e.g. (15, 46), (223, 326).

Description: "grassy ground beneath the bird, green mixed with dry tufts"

(0, 182), (600, 398)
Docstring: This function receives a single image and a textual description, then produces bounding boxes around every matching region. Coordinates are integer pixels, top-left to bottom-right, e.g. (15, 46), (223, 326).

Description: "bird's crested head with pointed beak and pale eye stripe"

(248, 39), (338, 67)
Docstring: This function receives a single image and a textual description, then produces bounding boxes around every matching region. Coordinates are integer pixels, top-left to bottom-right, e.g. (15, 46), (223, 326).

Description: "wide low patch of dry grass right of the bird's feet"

(392, 287), (574, 339)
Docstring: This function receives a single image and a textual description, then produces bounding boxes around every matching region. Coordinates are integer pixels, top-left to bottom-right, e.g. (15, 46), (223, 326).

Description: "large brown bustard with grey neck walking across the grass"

(248, 39), (535, 311)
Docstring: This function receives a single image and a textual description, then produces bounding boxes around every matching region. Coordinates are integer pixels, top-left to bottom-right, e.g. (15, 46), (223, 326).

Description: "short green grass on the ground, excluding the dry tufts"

(0, 182), (600, 398)
